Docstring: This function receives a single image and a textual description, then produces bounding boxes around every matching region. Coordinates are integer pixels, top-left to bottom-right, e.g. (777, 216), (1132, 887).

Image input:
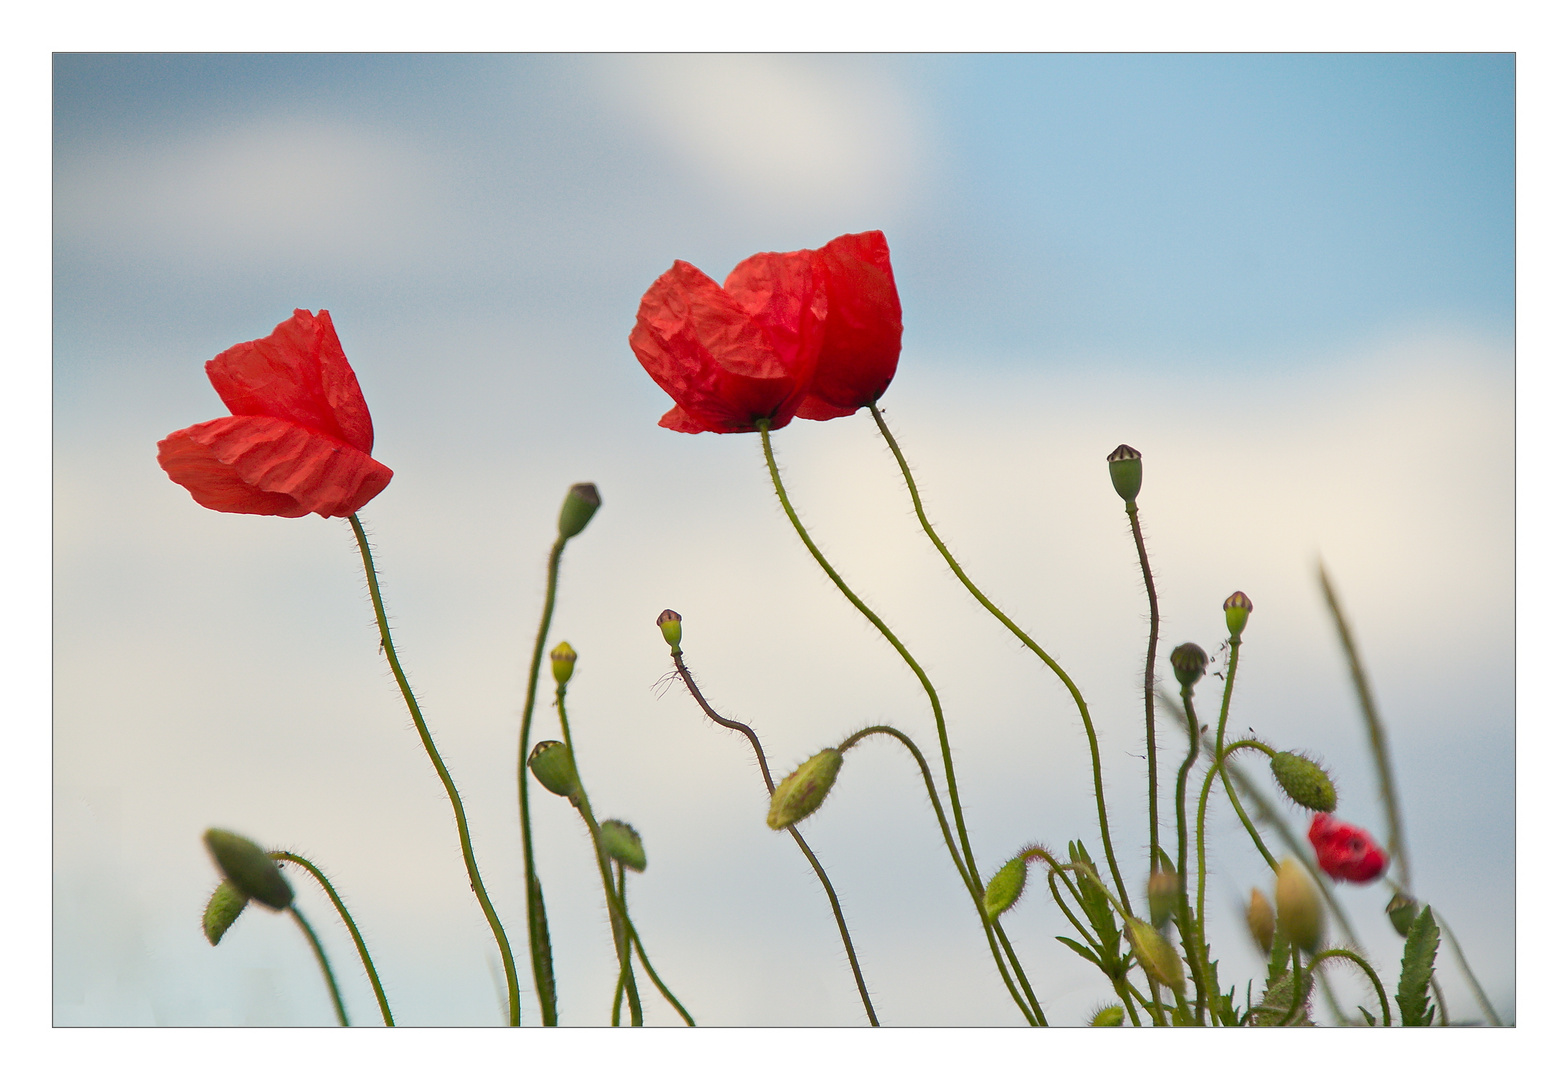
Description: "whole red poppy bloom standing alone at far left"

(158, 309), (392, 517)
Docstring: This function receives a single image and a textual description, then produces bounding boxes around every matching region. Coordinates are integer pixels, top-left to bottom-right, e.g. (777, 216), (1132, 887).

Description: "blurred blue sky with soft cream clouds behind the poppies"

(53, 55), (1515, 1025)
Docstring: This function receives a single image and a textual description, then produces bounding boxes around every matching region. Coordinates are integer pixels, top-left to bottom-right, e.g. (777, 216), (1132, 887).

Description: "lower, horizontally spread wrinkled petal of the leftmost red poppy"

(158, 417), (392, 517)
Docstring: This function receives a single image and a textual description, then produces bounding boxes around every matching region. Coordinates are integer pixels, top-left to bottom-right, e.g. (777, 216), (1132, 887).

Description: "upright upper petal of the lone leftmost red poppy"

(207, 309), (375, 455)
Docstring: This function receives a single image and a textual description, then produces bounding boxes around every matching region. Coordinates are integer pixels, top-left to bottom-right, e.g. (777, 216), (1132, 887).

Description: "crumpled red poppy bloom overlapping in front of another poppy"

(629, 251), (828, 433)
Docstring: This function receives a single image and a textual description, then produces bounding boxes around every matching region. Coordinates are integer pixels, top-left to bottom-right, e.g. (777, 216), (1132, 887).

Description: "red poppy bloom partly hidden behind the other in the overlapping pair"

(795, 230), (903, 420)
